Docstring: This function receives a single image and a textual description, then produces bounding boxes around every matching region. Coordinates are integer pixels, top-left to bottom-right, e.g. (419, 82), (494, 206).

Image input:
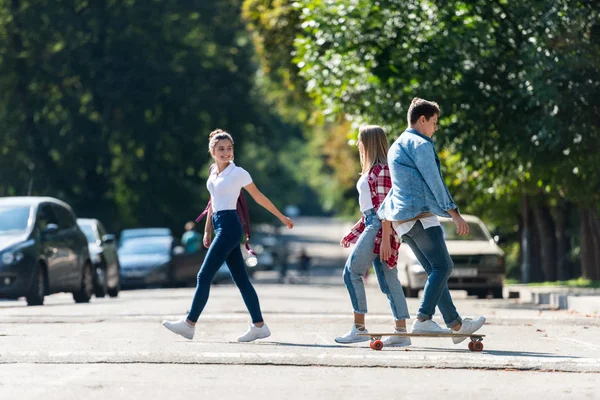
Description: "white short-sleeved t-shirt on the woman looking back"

(206, 162), (252, 212)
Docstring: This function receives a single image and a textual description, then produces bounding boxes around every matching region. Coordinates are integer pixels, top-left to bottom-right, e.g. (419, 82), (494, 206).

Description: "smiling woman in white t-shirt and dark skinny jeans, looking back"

(163, 129), (294, 342)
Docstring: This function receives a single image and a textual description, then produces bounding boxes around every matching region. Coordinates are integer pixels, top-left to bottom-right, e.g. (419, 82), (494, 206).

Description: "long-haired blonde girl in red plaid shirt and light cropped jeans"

(335, 125), (411, 346)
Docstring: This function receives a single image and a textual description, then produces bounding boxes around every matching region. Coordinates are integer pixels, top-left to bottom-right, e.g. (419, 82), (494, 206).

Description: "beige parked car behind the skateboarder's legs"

(398, 215), (506, 298)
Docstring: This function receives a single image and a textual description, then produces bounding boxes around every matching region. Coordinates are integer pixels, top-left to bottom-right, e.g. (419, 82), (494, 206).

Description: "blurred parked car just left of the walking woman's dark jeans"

(118, 236), (205, 287)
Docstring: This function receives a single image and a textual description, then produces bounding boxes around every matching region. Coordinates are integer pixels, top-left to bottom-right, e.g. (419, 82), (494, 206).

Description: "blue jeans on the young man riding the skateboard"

(402, 221), (462, 328)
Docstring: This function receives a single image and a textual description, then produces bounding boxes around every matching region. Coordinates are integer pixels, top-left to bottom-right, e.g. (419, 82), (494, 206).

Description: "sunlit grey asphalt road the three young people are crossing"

(0, 217), (600, 400)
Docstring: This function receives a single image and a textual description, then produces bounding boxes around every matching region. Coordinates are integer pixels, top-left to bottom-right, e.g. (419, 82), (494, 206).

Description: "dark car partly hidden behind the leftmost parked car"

(77, 218), (121, 297)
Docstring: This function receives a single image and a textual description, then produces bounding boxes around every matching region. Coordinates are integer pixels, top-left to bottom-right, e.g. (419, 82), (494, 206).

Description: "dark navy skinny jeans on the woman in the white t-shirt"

(187, 210), (263, 323)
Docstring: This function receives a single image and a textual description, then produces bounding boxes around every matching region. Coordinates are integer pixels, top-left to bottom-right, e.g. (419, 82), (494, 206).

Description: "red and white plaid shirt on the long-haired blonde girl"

(343, 164), (400, 269)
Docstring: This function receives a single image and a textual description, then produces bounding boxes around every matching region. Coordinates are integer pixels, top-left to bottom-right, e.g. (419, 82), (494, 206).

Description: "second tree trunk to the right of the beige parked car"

(533, 203), (556, 281)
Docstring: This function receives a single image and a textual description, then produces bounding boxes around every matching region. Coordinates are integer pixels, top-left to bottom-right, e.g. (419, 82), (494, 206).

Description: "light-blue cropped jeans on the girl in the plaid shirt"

(343, 209), (410, 320)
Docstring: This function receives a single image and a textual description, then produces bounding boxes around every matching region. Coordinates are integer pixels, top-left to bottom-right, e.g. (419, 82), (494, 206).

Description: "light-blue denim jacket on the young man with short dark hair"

(377, 128), (458, 221)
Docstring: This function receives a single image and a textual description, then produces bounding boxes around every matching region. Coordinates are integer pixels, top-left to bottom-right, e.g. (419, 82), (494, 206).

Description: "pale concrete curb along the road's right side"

(503, 285), (600, 316)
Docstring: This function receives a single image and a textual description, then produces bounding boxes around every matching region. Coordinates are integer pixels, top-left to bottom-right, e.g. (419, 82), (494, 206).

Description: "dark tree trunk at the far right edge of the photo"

(579, 206), (600, 281)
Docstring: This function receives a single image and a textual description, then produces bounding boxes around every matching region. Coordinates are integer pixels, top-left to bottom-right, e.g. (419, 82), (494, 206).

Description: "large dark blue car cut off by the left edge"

(0, 197), (93, 306)
